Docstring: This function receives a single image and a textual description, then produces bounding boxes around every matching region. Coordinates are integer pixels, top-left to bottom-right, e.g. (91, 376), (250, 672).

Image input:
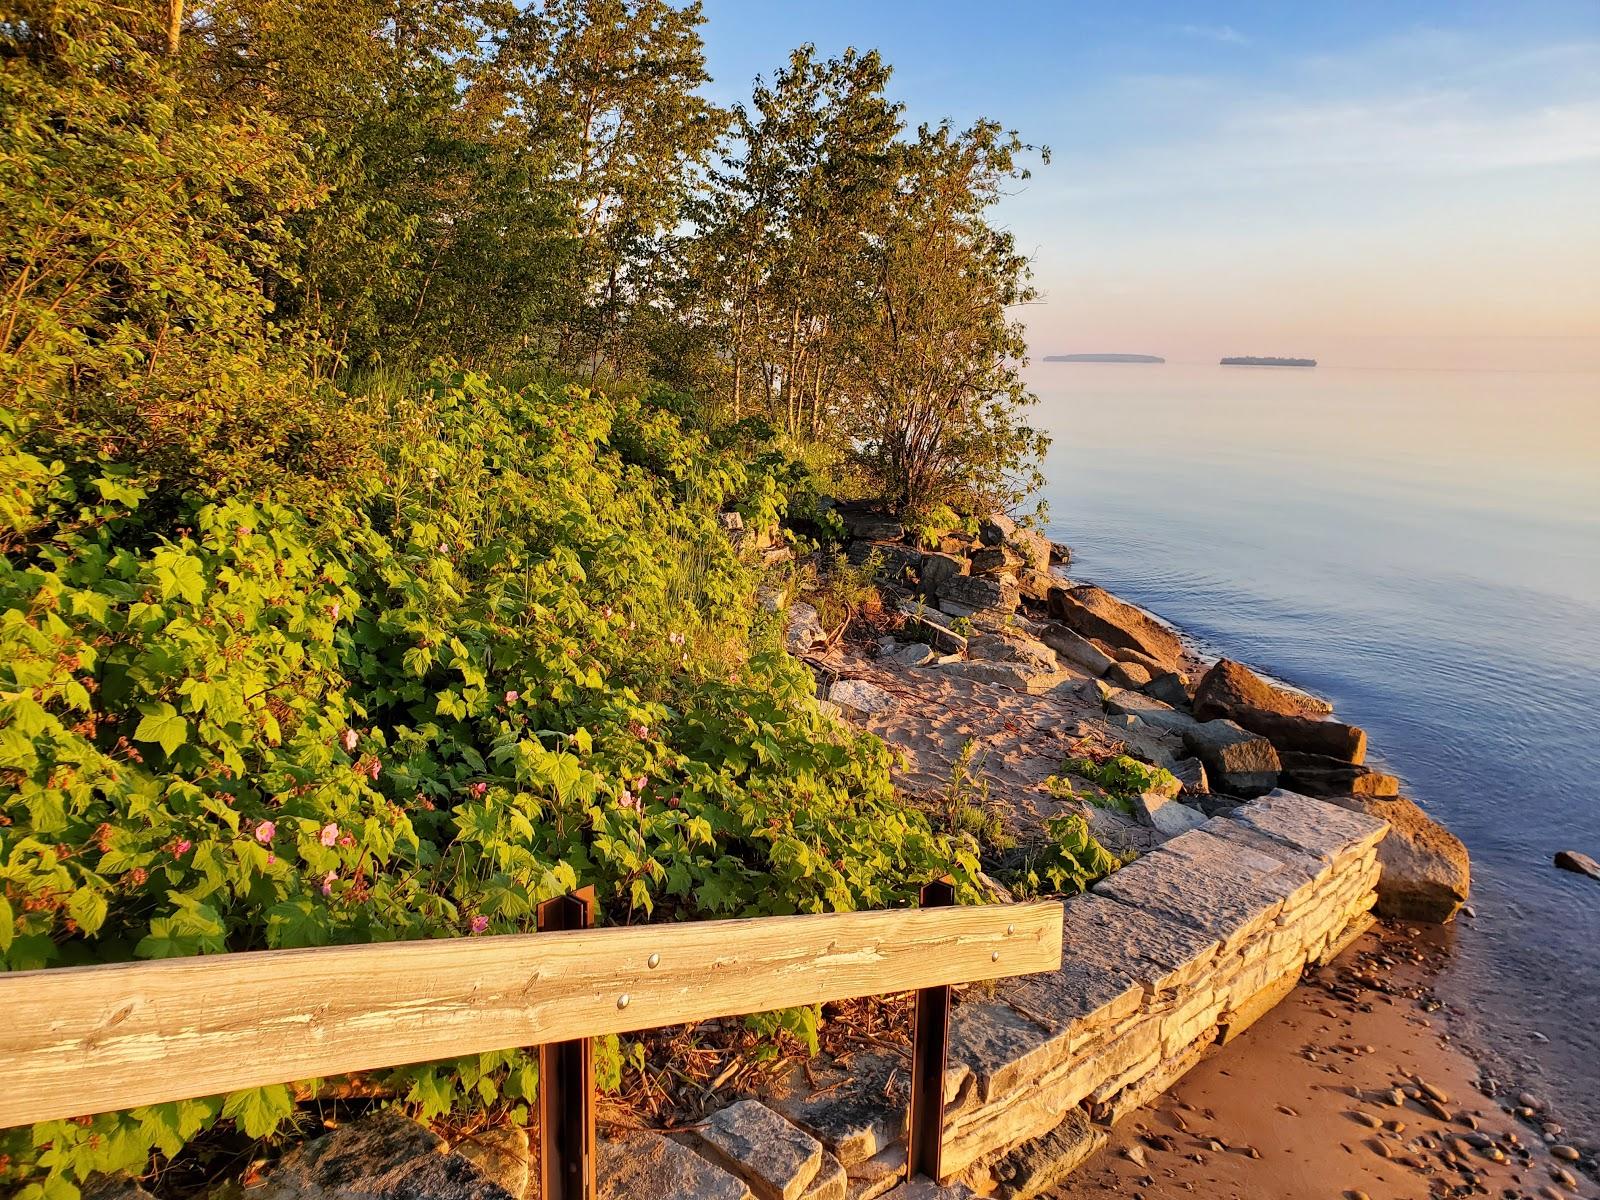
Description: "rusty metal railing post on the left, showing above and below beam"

(538, 888), (597, 1200)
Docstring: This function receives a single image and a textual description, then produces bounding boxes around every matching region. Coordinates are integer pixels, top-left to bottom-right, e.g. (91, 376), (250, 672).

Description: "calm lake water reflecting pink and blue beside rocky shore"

(1030, 363), (1600, 1136)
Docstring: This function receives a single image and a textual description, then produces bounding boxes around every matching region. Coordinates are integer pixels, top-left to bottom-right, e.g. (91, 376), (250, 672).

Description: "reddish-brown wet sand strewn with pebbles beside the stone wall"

(1048, 926), (1600, 1200)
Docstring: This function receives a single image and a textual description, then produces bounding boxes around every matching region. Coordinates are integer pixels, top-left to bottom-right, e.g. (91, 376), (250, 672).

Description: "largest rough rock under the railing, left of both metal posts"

(250, 1109), (515, 1200)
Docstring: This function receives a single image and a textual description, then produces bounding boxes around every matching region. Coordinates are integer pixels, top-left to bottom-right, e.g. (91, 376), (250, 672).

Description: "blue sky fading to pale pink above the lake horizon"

(702, 0), (1600, 370)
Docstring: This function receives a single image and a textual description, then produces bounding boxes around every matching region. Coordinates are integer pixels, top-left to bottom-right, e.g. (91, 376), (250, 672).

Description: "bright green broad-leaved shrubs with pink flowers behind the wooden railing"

(0, 374), (978, 1200)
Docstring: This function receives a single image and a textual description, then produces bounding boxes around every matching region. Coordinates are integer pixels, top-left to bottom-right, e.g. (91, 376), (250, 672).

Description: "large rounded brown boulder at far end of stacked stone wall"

(1328, 795), (1472, 925)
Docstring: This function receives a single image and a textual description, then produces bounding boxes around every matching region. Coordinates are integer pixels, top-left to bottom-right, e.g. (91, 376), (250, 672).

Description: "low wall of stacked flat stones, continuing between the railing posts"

(602, 790), (1387, 1200)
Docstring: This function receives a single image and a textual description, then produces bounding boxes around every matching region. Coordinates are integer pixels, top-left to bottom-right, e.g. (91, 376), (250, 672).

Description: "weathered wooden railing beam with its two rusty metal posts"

(0, 882), (1062, 1200)
